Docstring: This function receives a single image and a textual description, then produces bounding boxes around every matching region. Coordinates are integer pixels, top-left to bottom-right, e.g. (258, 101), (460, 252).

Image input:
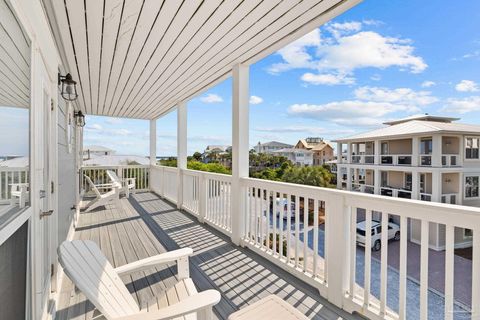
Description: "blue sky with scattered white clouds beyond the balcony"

(1, 0), (480, 155)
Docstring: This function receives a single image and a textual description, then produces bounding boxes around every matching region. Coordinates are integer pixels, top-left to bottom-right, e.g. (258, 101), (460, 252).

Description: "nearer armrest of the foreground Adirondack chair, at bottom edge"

(116, 290), (221, 320)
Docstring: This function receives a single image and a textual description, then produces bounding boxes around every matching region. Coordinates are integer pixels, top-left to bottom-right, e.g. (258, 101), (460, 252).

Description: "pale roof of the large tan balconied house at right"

(336, 120), (480, 142)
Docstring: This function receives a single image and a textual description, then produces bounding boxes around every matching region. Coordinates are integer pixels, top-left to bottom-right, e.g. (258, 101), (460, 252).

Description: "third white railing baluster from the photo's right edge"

(420, 220), (429, 320)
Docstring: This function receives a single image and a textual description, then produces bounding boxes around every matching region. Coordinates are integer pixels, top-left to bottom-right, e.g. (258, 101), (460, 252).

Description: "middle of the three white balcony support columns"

(177, 102), (187, 209)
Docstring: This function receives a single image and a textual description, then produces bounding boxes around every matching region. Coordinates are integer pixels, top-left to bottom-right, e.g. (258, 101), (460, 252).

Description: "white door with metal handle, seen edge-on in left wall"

(32, 53), (56, 319)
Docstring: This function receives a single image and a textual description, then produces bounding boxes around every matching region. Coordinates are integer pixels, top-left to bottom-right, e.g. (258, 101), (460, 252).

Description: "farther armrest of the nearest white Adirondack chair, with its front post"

(115, 248), (193, 278)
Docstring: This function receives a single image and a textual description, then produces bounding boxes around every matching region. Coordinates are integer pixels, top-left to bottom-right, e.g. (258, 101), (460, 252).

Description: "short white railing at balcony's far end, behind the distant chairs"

(81, 165), (150, 193)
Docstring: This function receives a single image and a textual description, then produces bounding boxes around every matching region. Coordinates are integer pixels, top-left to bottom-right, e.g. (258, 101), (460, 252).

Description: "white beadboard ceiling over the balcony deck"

(43, 0), (360, 119)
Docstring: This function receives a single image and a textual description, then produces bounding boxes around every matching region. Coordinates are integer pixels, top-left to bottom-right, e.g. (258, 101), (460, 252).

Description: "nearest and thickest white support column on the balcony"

(230, 64), (249, 245)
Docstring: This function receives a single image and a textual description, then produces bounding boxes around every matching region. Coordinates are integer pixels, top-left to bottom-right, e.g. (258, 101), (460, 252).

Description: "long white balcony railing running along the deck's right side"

(150, 166), (480, 319)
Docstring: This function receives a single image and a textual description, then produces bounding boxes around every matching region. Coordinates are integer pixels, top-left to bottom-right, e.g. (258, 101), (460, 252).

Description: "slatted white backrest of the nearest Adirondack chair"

(58, 240), (140, 319)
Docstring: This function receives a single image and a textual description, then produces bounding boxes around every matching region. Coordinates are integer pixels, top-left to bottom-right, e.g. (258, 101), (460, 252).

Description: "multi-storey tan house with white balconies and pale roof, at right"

(336, 115), (480, 250)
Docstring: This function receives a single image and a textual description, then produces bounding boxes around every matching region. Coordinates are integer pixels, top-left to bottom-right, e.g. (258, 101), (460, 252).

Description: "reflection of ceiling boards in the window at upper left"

(0, 0), (31, 108)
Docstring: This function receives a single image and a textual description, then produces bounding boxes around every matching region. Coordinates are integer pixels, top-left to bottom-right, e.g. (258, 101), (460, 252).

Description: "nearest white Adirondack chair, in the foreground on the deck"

(58, 240), (220, 320)
